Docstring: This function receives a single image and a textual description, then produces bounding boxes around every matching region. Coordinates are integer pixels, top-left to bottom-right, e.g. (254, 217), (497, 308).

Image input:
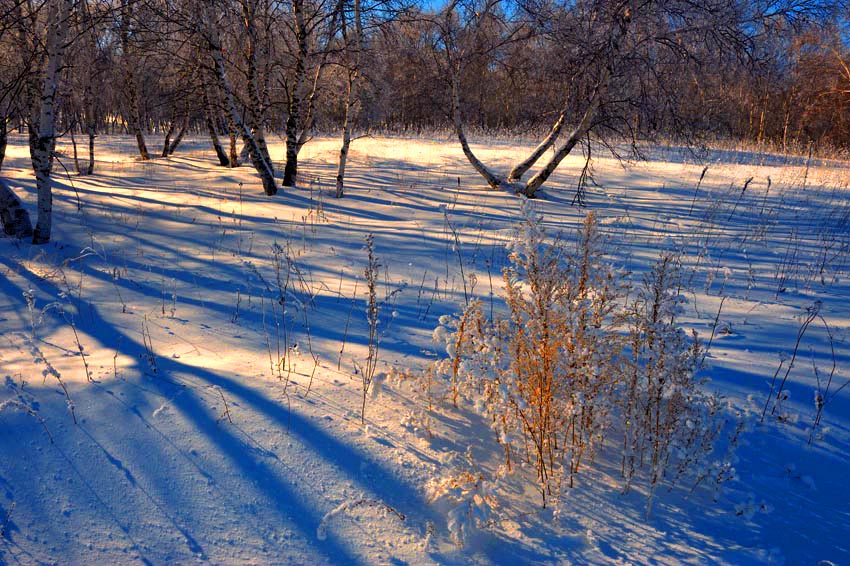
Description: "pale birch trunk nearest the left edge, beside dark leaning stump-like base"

(30, 0), (73, 244)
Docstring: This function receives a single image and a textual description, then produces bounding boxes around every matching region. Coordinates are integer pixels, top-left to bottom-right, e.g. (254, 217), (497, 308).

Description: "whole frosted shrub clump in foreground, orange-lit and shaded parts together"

(429, 204), (724, 520)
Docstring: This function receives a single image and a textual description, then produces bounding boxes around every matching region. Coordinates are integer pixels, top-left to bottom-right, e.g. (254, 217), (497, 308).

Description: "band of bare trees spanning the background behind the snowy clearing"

(0, 0), (850, 243)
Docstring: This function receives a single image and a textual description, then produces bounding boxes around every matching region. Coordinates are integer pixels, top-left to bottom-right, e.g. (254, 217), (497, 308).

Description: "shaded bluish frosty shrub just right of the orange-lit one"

(616, 253), (724, 512)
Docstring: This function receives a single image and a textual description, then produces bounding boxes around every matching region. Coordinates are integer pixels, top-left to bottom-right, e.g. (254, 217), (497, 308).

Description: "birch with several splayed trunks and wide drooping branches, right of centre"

(444, 0), (836, 197)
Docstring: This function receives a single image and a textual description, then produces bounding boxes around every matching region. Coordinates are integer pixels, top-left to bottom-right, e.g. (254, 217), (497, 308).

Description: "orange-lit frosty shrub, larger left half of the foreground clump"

(434, 205), (622, 506)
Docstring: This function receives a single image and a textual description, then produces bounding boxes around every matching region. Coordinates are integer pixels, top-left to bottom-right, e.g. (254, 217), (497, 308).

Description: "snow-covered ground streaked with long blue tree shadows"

(0, 137), (850, 564)
